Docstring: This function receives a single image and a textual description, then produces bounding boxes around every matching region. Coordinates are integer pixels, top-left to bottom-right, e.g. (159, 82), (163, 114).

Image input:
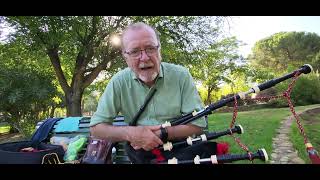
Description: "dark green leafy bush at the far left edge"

(0, 41), (57, 136)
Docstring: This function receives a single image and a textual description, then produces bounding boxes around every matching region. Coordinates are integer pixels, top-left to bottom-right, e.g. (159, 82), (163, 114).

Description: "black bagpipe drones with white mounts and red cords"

(154, 64), (320, 164)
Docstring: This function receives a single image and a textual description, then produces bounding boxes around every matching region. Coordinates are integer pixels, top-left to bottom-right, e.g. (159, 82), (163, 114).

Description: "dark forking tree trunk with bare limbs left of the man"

(47, 26), (120, 116)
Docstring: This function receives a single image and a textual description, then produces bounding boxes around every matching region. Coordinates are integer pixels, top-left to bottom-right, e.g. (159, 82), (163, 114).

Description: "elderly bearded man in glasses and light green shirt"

(90, 23), (215, 163)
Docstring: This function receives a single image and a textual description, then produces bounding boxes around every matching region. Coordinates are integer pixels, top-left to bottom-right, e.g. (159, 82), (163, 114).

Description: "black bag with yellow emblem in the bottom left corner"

(0, 141), (64, 164)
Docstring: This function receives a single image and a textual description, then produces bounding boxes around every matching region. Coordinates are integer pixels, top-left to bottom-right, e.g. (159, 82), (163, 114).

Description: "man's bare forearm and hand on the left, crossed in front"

(90, 123), (163, 151)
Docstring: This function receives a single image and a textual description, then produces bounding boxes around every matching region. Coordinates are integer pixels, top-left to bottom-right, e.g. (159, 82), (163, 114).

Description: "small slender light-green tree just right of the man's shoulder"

(190, 37), (242, 104)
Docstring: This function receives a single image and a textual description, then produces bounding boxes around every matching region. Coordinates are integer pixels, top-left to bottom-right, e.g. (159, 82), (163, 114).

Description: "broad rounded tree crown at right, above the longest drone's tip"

(248, 32), (320, 75)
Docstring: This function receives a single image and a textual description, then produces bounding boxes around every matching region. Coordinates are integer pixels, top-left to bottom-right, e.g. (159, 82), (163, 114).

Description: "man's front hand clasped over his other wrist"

(129, 125), (163, 151)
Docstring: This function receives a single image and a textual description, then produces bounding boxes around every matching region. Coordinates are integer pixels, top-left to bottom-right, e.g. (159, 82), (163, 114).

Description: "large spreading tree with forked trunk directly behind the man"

(4, 16), (225, 116)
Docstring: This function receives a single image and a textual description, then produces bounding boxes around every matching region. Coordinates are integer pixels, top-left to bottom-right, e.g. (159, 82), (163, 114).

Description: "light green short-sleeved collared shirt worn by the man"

(90, 62), (206, 127)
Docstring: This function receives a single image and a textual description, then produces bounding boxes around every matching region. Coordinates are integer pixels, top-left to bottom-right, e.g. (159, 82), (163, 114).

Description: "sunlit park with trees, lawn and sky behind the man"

(0, 16), (320, 163)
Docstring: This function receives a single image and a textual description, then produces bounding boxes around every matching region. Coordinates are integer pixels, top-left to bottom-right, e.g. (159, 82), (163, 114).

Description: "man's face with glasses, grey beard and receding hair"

(123, 28), (161, 84)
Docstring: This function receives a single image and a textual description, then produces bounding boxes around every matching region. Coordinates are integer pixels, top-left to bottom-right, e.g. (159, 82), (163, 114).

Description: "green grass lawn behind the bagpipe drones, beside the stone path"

(208, 105), (320, 164)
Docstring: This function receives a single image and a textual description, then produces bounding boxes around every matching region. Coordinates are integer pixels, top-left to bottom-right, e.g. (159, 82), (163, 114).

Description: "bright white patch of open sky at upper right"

(225, 16), (320, 57)
